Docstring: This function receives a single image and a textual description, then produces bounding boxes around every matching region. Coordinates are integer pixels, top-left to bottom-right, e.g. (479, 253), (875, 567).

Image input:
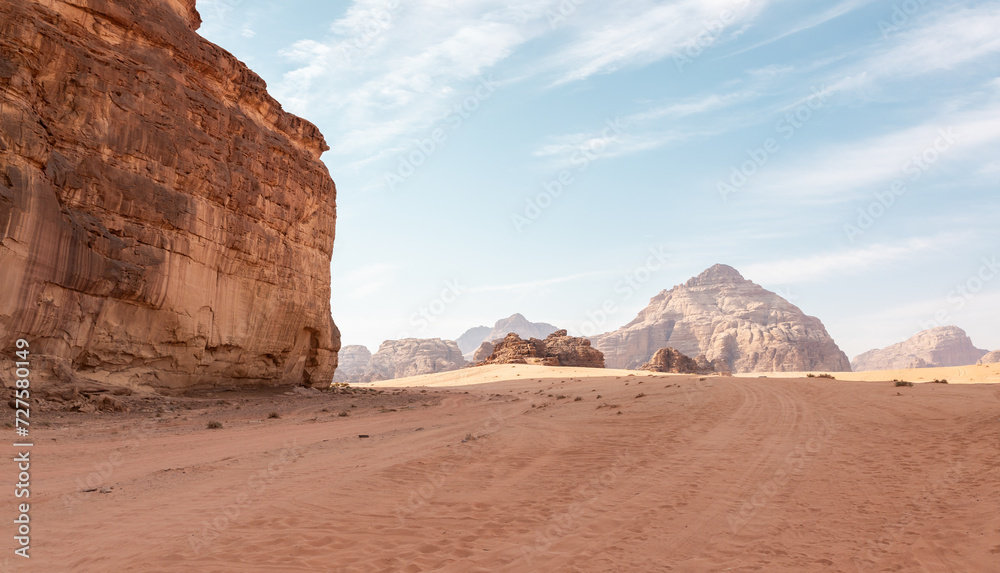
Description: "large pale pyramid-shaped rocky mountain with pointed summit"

(592, 265), (851, 372)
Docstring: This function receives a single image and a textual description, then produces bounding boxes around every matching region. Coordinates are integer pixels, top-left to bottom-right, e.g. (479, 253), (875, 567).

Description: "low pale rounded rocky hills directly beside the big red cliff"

(334, 338), (467, 384)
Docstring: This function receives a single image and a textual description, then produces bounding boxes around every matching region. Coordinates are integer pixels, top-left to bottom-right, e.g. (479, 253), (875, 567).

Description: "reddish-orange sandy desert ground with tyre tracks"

(0, 366), (1000, 572)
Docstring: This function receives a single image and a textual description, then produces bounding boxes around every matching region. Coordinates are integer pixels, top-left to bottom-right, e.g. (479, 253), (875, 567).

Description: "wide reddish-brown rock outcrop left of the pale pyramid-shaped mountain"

(477, 330), (604, 368)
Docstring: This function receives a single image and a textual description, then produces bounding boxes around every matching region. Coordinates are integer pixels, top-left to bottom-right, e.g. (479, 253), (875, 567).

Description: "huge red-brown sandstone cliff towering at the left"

(0, 0), (340, 388)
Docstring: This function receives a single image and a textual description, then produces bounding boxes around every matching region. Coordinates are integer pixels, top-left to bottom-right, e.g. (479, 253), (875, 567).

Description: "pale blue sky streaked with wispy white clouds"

(198, 0), (1000, 357)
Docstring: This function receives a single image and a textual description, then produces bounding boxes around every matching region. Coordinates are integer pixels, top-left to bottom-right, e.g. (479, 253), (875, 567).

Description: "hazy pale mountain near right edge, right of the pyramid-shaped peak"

(851, 326), (987, 372)
